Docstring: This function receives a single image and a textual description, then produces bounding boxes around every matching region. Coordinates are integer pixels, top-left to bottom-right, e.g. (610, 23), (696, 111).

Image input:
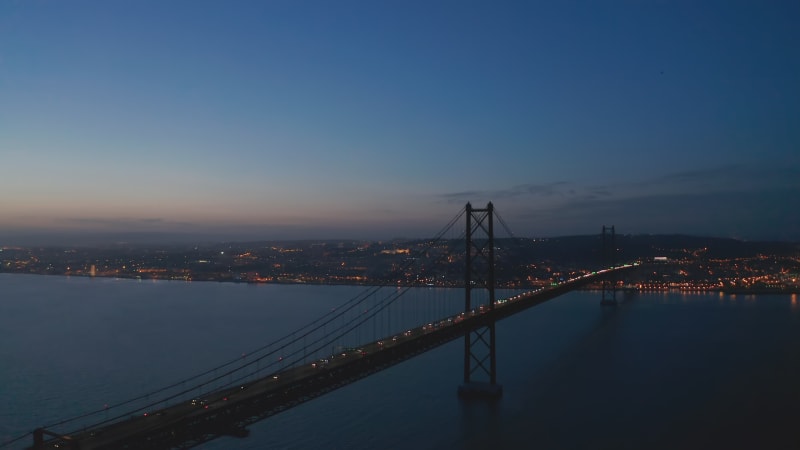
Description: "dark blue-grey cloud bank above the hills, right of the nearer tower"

(462, 165), (800, 240)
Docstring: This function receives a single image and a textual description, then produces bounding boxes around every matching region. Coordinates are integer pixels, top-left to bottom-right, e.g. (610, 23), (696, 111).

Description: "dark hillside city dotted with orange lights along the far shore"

(0, 237), (800, 292)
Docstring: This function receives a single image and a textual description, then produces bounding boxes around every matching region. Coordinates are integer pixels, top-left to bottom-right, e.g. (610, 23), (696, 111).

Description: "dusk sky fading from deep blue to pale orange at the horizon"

(0, 0), (800, 244)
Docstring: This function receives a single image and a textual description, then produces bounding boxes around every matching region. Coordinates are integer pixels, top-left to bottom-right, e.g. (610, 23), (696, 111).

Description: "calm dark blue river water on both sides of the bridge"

(0, 274), (800, 450)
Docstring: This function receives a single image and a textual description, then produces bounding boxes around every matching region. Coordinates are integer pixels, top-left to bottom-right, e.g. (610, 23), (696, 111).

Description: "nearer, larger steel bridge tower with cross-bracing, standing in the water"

(458, 202), (503, 398)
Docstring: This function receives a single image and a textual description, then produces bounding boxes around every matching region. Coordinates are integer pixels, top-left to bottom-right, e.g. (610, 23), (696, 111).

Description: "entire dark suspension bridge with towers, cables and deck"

(6, 203), (638, 450)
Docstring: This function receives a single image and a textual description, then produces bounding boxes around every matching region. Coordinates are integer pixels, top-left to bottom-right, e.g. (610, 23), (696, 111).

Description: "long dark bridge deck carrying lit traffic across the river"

(31, 264), (636, 450)
